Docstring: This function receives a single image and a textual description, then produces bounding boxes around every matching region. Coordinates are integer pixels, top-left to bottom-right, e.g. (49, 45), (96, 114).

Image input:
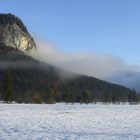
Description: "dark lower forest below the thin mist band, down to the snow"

(0, 66), (140, 104)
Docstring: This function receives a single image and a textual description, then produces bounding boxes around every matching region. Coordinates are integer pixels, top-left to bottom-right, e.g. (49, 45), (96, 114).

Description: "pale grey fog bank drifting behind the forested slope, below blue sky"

(32, 41), (140, 91)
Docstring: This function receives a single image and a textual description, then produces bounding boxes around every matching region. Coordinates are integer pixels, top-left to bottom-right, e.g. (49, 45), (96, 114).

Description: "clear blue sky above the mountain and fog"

(0, 0), (140, 65)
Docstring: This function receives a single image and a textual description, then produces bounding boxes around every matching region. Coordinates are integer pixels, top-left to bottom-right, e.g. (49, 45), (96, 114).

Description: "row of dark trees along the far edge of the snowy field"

(0, 69), (140, 105)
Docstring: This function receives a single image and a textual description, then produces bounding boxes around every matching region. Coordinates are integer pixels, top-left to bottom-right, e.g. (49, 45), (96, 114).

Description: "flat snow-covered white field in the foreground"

(0, 104), (140, 140)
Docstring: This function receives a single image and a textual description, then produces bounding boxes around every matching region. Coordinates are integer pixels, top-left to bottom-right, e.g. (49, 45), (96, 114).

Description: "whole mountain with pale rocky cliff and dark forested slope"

(0, 14), (137, 103)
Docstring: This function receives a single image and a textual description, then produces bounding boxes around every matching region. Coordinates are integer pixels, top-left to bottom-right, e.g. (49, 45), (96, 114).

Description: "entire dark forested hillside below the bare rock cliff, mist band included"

(0, 44), (138, 103)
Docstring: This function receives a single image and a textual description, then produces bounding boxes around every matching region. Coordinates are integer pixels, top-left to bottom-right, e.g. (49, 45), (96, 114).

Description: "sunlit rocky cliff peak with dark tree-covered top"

(0, 14), (36, 53)
